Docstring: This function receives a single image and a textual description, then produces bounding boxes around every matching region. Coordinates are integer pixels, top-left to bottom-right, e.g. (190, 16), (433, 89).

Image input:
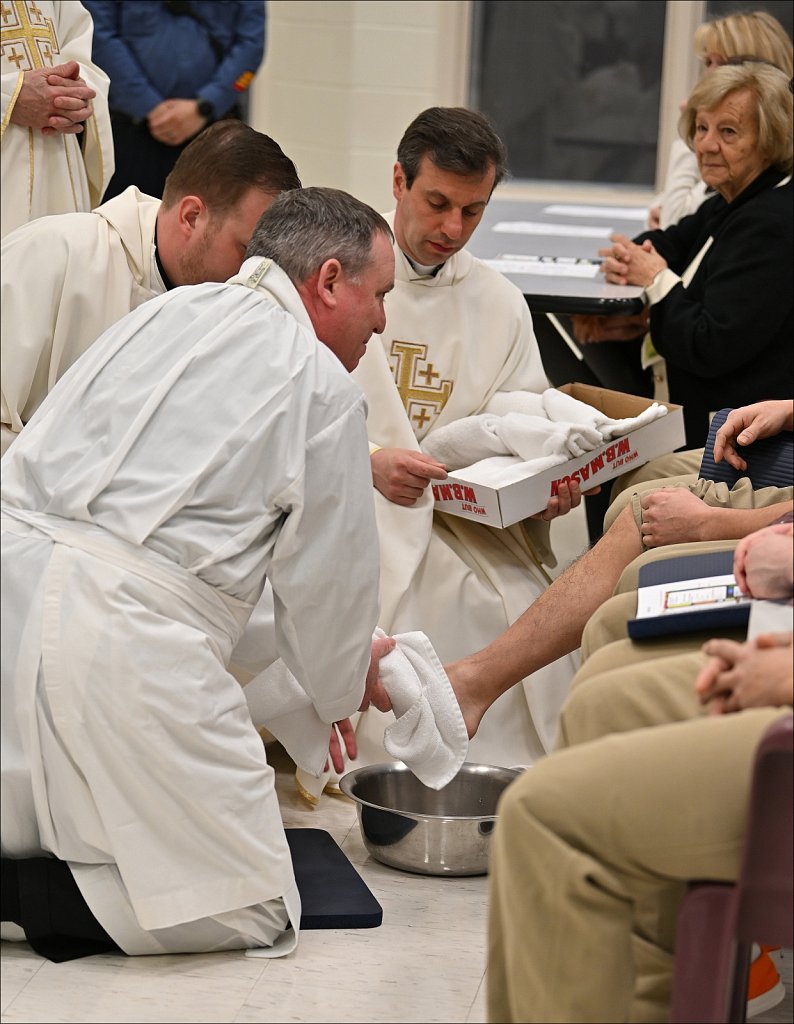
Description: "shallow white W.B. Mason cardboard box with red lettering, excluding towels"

(432, 384), (684, 527)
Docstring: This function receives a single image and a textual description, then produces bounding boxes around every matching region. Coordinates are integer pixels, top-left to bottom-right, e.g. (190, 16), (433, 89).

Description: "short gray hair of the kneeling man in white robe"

(246, 187), (393, 285)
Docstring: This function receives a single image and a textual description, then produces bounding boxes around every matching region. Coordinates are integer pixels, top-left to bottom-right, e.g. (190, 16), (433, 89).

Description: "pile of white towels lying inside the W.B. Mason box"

(422, 388), (667, 483)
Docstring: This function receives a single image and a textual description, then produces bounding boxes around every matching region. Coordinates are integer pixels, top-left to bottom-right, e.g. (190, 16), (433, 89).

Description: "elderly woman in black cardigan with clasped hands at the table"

(600, 61), (794, 446)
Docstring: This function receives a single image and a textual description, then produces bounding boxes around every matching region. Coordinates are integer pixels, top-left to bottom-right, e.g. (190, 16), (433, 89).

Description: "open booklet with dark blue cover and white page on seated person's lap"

(628, 551), (753, 640)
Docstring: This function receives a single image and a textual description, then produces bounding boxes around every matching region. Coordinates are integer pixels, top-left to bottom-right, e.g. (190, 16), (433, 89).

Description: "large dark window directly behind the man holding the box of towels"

(470, 0), (666, 187)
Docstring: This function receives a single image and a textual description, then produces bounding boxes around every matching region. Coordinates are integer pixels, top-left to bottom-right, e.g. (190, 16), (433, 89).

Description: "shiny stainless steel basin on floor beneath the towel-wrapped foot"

(339, 763), (520, 876)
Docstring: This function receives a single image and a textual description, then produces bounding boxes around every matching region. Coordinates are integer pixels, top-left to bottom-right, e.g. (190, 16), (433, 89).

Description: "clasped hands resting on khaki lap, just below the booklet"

(695, 633), (794, 715)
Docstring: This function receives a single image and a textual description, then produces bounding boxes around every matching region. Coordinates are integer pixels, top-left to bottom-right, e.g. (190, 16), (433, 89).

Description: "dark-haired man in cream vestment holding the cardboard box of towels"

(317, 108), (581, 786)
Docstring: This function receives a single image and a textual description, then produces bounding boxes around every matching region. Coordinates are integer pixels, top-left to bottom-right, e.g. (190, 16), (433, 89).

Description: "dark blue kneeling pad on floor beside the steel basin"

(285, 828), (383, 929)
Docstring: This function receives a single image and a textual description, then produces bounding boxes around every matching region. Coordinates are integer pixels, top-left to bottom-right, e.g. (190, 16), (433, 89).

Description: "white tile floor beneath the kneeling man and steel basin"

(0, 505), (792, 1024)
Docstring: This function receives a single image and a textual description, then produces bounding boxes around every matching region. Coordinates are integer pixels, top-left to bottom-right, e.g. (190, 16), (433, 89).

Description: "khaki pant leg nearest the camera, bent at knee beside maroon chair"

(488, 709), (782, 1022)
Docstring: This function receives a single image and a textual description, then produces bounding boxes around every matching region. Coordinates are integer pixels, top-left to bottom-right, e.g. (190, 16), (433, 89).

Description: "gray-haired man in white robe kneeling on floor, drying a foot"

(2, 188), (394, 961)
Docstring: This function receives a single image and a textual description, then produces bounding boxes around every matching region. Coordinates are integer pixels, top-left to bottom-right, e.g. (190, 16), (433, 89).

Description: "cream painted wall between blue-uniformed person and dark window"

(250, 0), (470, 210)
